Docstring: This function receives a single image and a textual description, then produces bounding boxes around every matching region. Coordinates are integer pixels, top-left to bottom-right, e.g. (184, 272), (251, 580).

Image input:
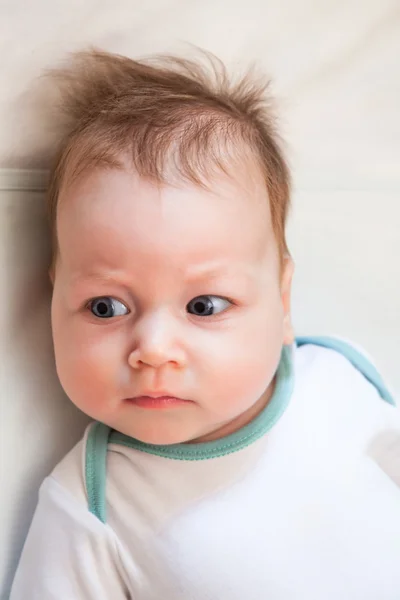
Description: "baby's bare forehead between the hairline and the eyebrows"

(58, 169), (273, 274)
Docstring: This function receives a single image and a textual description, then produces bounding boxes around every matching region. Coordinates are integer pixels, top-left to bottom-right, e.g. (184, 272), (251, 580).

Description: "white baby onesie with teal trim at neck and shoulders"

(11, 338), (400, 600)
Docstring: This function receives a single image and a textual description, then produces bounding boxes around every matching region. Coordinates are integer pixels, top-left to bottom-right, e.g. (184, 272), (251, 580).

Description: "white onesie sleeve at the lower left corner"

(10, 477), (130, 600)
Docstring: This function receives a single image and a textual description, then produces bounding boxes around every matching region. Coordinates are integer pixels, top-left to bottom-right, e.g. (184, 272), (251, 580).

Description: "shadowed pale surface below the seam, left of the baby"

(0, 183), (88, 598)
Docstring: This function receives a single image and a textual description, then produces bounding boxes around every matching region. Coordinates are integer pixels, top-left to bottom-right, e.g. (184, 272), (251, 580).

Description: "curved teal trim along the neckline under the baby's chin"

(109, 346), (294, 460)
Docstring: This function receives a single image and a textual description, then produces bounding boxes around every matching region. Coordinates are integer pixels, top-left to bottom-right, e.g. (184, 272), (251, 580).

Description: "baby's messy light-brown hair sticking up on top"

(48, 50), (290, 261)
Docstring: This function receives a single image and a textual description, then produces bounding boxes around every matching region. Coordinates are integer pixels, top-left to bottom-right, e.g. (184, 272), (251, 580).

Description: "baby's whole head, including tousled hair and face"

(49, 52), (293, 444)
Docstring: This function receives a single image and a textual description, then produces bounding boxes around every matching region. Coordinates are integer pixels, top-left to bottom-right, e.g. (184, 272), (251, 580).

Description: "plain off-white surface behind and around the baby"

(0, 0), (400, 599)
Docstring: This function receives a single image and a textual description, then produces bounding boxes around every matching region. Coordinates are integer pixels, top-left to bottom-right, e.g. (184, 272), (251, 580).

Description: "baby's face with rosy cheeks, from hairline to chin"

(52, 169), (292, 444)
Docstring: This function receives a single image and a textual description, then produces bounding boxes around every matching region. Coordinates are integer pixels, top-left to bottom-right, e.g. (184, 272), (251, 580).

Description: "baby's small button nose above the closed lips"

(128, 312), (185, 369)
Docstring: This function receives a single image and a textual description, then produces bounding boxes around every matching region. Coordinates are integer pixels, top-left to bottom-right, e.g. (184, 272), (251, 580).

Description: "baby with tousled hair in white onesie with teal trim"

(11, 51), (400, 600)
